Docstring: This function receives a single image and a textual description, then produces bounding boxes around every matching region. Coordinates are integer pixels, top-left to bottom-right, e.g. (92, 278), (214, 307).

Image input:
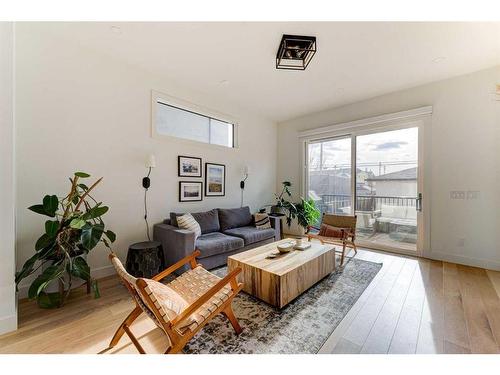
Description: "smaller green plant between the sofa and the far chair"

(271, 181), (321, 230)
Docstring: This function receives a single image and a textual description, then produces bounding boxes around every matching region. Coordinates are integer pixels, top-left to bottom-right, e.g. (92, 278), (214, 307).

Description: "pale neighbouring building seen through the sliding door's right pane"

(366, 167), (417, 197)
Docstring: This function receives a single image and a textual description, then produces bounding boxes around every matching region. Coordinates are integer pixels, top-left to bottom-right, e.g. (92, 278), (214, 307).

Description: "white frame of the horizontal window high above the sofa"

(151, 90), (238, 150)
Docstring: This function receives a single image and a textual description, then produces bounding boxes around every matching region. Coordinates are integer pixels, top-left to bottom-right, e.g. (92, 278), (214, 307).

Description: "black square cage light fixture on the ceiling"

(276, 34), (316, 70)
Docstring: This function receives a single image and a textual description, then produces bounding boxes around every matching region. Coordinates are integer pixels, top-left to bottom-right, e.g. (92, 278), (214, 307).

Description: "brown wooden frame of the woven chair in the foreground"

(101, 250), (243, 354)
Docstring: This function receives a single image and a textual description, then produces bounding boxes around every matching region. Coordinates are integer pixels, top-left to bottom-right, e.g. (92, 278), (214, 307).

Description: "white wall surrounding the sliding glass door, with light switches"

(277, 67), (500, 270)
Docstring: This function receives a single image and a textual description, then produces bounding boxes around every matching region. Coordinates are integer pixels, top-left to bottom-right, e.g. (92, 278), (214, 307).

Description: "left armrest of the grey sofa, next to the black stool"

(153, 224), (195, 268)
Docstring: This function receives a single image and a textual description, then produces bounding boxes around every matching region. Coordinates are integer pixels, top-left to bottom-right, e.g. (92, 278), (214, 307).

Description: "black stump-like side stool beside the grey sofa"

(125, 241), (164, 279)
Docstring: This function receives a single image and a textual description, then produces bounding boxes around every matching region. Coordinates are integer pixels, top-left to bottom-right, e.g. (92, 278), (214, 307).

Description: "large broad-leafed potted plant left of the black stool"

(16, 172), (116, 308)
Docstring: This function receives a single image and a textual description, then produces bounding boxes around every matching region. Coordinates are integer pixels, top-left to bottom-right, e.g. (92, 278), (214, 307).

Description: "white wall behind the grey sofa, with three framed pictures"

(16, 23), (277, 296)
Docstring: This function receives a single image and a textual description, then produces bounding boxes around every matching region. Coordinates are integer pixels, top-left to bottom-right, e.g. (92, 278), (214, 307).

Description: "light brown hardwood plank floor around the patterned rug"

(0, 250), (500, 354)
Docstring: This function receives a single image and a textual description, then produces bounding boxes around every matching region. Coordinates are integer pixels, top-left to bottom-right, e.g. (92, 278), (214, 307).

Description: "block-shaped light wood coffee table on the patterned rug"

(227, 239), (335, 308)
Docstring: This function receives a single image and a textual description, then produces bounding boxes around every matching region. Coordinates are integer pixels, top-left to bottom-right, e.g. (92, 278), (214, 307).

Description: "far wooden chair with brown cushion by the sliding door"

(306, 213), (358, 265)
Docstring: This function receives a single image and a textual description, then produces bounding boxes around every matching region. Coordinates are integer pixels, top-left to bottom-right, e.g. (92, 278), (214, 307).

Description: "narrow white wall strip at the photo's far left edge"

(0, 22), (17, 334)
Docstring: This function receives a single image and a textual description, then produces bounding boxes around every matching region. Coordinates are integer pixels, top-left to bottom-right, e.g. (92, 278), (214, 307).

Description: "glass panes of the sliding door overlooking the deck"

(306, 126), (421, 253)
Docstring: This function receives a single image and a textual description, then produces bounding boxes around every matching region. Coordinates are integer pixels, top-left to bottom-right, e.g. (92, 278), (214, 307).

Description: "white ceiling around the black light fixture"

(40, 22), (500, 121)
